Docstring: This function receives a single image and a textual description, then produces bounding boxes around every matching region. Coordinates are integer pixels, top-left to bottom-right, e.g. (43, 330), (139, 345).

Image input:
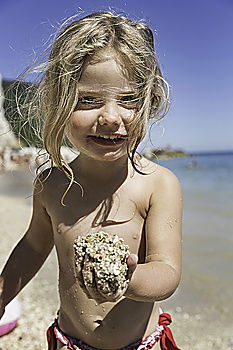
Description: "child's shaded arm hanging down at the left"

(0, 189), (54, 318)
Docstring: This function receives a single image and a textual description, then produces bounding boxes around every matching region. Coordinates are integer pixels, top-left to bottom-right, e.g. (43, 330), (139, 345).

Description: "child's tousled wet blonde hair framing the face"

(17, 12), (169, 194)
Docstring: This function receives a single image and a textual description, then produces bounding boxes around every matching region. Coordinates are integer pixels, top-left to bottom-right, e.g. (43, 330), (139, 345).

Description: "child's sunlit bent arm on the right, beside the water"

(125, 170), (182, 302)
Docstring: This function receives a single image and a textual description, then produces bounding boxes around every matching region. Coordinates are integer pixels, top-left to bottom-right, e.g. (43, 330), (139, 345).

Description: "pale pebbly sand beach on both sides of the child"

(0, 171), (233, 350)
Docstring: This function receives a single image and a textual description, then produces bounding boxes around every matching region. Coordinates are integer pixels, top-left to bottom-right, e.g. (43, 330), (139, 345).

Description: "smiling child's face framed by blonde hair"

(68, 54), (137, 161)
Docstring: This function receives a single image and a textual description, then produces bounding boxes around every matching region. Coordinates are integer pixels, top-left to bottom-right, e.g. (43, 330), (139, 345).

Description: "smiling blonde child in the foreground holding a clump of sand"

(0, 12), (182, 350)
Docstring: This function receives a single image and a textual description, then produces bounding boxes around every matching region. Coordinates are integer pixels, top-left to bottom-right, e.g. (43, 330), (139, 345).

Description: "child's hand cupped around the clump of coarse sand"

(76, 254), (138, 304)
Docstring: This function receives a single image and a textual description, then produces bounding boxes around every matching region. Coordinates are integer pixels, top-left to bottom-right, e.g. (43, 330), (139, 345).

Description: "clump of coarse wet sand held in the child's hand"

(74, 231), (130, 295)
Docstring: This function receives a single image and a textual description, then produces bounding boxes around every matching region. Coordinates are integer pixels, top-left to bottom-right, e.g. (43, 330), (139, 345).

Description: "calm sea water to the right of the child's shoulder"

(159, 152), (233, 322)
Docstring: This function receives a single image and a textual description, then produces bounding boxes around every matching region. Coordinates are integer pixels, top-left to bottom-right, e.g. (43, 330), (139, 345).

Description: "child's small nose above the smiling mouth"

(98, 101), (121, 125)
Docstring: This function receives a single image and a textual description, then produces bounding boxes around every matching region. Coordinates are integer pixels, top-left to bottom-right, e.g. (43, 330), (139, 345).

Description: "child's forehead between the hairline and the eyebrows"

(78, 54), (135, 92)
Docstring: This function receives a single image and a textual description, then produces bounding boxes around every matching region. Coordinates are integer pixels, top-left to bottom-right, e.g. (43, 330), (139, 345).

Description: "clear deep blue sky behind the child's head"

(0, 0), (233, 151)
